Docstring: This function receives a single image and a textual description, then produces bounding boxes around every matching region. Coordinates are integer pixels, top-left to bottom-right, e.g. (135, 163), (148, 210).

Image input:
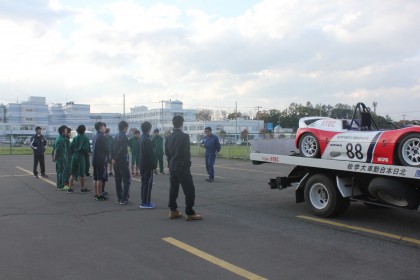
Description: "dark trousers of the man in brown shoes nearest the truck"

(168, 169), (195, 215)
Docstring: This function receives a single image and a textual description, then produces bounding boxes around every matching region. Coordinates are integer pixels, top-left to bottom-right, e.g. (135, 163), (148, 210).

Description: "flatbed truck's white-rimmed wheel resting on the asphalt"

(305, 174), (350, 218)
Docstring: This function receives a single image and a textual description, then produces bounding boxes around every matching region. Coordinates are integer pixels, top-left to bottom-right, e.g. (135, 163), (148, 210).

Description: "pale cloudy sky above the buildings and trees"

(0, 0), (420, 120)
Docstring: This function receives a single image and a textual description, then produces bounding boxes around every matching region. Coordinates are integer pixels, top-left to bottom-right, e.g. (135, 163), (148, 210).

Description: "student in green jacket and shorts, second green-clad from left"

(67, 124), (90, 193)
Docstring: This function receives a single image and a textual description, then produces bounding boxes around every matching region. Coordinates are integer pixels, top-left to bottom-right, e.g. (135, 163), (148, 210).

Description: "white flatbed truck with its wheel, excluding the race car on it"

(250, 152), (420, 217)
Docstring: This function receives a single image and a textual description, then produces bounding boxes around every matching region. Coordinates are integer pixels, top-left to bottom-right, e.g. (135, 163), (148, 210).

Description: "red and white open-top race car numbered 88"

(295, 103), (420, 167)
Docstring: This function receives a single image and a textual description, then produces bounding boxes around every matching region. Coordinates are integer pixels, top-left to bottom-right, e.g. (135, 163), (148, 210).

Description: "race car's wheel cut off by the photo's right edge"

(398, 133), (420, 167)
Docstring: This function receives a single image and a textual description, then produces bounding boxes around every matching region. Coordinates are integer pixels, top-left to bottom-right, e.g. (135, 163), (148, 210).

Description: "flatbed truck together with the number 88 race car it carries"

(250, 103), (420, 217)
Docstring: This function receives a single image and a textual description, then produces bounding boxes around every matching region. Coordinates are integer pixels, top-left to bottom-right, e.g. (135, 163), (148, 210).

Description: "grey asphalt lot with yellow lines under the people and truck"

(0, 156), (420, 280)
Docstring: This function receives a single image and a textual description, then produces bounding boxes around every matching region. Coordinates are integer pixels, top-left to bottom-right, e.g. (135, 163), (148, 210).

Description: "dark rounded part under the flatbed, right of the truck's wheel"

(368, 177), (420, 210)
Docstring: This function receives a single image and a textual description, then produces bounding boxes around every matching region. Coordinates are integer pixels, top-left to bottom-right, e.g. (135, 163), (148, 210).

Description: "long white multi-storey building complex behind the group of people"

(0, 96), (264, 143)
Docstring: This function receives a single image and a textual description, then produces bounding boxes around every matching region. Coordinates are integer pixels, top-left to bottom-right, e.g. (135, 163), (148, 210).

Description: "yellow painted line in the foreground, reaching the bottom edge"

(162, 237), (266, 280)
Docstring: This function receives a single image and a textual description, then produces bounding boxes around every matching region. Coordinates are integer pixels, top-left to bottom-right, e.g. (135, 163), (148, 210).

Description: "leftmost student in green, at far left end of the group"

(53, 125), (67, 191)
